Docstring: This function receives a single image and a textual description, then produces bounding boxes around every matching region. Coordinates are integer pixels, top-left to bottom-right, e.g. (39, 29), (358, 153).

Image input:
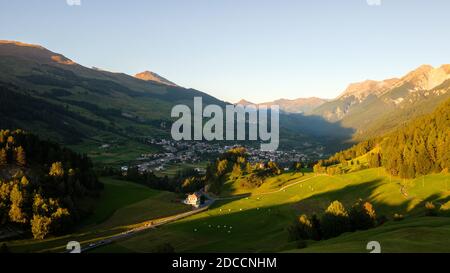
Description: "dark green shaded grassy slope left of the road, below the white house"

(8, 178), (190, 252)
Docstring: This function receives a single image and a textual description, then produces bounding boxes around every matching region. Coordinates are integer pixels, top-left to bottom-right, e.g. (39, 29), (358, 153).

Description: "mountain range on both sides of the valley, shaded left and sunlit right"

(0, 41), (450, 156)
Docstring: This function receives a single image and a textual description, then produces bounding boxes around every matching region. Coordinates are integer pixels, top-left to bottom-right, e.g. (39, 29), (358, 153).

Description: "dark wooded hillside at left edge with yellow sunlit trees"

(0, 130), (102, 239)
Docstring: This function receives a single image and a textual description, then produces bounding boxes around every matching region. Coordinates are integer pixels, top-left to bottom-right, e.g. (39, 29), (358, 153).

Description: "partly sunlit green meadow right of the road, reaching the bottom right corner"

(94, 168), (450, 252)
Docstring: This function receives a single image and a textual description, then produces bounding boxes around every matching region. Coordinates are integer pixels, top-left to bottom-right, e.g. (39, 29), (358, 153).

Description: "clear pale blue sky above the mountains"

(0, 0), (450, 103)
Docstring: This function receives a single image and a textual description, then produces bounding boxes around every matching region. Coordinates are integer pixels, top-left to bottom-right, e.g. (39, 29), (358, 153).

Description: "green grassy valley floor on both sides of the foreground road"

(3, 168), (450, 252)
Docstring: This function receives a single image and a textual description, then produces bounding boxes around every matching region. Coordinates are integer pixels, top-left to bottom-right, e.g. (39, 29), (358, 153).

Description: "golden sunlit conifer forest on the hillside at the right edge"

(315, 96), (450, 178)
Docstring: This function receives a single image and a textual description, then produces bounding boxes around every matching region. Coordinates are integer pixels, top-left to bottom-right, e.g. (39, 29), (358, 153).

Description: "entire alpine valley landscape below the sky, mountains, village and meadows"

(0, 40), (450, 253)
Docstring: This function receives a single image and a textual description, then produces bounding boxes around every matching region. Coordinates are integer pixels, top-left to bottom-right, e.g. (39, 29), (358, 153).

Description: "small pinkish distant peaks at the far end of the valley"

(236, 97), (328, 114)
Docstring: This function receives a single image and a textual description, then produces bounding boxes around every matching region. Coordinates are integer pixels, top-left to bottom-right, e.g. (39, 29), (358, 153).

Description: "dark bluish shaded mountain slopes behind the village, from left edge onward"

(0, 39), (353, 154)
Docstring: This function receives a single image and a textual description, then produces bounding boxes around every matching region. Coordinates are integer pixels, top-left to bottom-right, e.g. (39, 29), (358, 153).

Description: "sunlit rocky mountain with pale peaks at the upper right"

(312, 65), (450, 139)
